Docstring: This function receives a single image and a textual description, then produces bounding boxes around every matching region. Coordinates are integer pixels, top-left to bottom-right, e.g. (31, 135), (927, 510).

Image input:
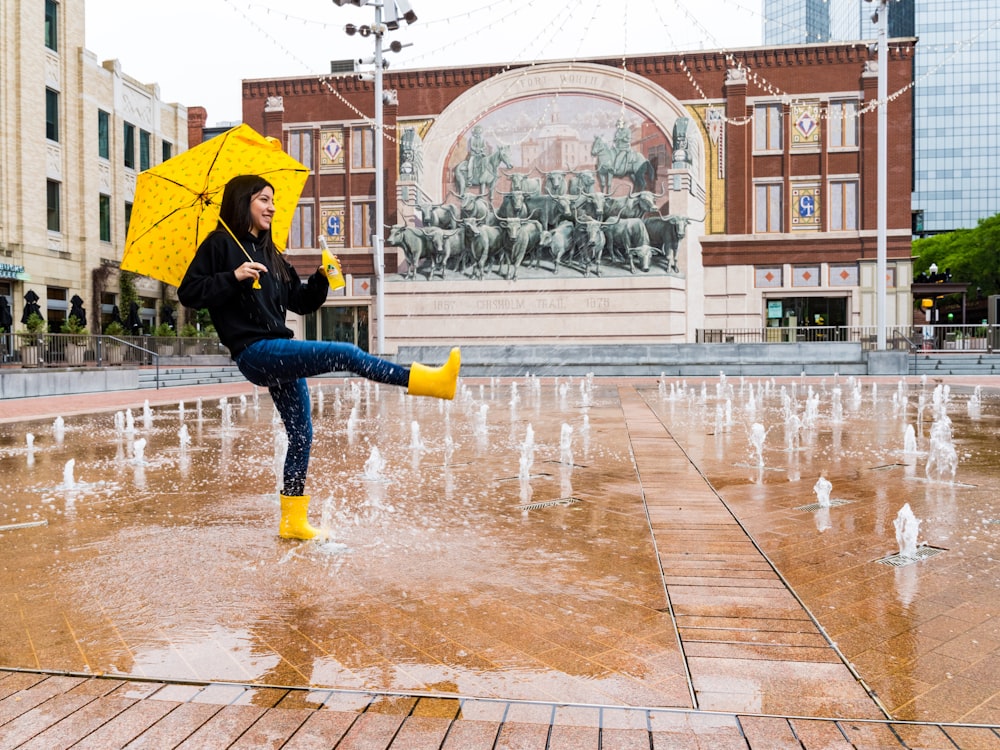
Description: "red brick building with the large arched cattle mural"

(243, 39), (915, 353)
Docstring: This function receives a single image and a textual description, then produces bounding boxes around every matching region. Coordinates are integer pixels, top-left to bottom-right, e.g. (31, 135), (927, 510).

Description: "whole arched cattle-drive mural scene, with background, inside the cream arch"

(386, 93), (692, 281)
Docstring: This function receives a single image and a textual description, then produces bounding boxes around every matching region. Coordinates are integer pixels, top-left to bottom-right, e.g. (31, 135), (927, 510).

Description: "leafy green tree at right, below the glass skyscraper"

(913, 214), (1000, 295)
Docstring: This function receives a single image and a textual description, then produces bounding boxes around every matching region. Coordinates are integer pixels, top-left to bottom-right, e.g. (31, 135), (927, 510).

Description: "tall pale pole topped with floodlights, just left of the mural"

(333, 0), (417, 354)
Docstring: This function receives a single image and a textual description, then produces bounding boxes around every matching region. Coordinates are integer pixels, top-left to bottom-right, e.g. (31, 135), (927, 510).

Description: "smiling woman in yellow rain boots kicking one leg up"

(177, 175), (461, 539)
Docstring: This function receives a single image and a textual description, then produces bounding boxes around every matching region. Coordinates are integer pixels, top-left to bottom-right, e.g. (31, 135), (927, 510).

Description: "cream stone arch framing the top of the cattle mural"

(421, 62), (708, 206)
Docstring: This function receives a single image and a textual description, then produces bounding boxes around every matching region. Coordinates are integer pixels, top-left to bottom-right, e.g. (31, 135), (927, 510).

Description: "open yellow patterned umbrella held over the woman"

(121, 125), (309, 286)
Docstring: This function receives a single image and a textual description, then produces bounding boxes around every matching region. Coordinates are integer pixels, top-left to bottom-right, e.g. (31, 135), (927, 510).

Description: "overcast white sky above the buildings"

(85, 0), (762, 124)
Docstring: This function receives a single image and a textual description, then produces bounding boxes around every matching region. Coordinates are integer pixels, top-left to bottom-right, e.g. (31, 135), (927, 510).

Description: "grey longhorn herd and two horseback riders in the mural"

(386, 124), (692, 281)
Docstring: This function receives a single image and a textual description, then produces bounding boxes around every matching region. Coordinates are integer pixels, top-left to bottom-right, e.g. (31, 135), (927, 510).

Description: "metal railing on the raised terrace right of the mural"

(696, 325), (1000, 352)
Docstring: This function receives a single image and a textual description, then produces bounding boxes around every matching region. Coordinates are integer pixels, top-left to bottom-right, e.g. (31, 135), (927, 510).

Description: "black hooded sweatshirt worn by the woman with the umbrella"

(177, 229), (330, 359)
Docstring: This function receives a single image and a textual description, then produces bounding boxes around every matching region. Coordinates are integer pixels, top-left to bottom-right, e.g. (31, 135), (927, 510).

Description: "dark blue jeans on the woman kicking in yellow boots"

(236, 339), (410, 495)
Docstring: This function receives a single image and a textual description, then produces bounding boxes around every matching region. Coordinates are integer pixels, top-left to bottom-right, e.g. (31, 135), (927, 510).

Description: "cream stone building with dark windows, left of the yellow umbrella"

(0, 0), (188, 346)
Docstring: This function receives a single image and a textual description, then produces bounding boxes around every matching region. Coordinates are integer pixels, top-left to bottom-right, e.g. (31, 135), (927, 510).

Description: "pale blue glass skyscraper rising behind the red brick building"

(764, 0), (1000, 234)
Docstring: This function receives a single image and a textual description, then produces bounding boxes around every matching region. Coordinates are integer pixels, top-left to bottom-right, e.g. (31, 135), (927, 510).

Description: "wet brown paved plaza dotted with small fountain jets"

(0, 375), (1000, 749)
